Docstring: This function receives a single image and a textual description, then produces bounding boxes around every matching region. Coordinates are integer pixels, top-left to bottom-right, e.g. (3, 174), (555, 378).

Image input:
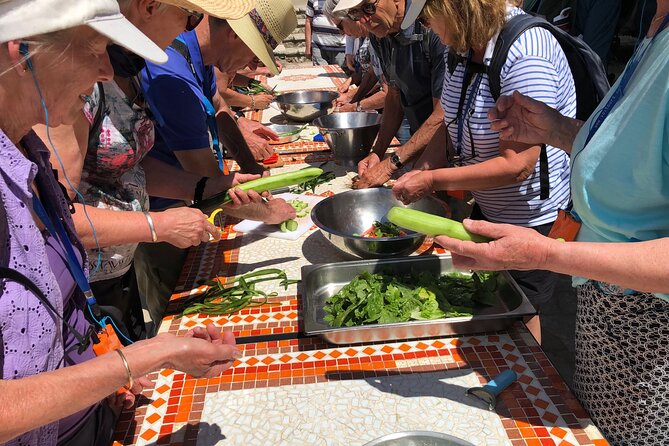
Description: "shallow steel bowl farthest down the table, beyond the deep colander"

(274, 90), (339, 122)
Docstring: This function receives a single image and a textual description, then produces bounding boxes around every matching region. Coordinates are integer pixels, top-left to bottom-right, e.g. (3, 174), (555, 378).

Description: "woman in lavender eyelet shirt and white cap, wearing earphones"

(0, 0), (245, 445)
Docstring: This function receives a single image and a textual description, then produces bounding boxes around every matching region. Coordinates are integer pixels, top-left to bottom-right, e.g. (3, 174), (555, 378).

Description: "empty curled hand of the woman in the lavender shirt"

(157, 324), (241, 378)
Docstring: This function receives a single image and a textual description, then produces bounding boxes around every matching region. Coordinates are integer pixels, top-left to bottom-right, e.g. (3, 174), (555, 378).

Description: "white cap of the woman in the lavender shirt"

(0, 0), (167, 64)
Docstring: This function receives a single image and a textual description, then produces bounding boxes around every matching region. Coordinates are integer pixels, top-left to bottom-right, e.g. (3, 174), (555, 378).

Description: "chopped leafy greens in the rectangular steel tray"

(324, 272), (497, 327)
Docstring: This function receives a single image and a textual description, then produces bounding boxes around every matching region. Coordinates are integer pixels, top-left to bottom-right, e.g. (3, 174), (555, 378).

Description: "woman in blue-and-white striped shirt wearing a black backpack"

(393, 0), (576, 341)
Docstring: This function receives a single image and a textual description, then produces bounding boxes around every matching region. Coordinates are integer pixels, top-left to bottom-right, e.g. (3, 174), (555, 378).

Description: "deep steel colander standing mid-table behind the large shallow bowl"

(314, 112), (381, 167)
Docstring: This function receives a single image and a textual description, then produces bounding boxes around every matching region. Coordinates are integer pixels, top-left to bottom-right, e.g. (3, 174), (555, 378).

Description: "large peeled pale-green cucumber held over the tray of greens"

(388, 207), (492, 243)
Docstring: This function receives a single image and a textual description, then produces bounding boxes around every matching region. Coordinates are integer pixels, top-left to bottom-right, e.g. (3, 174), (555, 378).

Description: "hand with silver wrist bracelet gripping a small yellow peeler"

(151, 207), (221, 248)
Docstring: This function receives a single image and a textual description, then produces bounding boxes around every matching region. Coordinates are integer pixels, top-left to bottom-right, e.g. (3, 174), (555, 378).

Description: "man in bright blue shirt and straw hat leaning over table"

(142, 0), (297, 216)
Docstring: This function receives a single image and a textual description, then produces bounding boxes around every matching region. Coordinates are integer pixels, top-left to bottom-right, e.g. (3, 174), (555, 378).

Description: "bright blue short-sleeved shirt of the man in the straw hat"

(142, 31), (216, 209)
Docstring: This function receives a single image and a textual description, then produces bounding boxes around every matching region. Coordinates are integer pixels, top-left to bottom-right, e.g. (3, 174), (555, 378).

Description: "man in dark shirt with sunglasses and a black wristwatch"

(334, 0), (444, 187)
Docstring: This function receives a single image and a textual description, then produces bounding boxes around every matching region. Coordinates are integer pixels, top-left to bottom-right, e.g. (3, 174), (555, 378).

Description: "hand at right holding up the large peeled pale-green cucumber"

(435, 219), (552, 271)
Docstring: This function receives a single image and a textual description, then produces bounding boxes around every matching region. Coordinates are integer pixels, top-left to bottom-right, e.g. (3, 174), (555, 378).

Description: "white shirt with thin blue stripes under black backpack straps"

(441, 8), (576, 227)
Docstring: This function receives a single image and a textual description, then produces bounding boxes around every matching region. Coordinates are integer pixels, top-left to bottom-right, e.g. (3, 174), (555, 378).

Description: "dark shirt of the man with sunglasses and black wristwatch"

(369, 13), (447, 133)
